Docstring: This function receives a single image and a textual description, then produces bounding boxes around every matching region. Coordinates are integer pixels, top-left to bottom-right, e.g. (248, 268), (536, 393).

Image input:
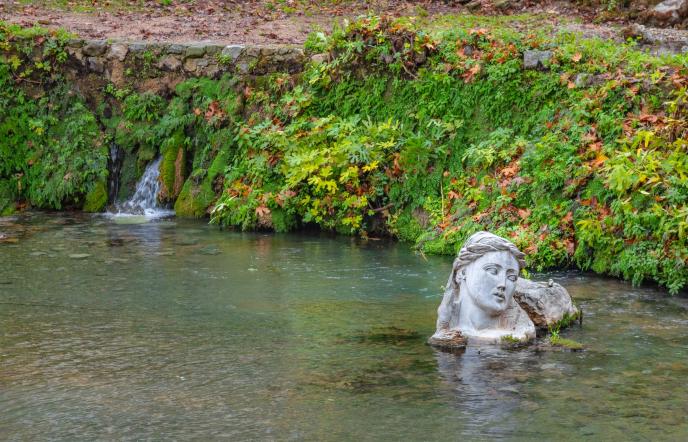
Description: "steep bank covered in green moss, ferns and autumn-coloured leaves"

(0, 17), (688, 293)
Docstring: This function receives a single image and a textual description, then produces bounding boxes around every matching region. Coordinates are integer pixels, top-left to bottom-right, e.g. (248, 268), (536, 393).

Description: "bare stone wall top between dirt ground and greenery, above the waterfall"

(67, 39), (306, 93)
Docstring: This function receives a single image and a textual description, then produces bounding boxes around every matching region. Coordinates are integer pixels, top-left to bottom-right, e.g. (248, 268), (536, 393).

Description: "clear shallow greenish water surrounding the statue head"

(0, 214), (688, 440)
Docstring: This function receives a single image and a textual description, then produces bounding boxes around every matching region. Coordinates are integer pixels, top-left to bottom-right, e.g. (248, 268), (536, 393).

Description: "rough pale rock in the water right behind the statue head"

(514, 278), (579, 328)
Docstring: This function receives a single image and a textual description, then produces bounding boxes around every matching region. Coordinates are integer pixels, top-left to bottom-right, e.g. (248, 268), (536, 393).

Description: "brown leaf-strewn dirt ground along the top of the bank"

(0, 0), (688, 52)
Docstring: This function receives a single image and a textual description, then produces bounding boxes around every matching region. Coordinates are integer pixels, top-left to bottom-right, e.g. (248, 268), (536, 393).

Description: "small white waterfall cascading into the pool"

(112, 157), (174, 219)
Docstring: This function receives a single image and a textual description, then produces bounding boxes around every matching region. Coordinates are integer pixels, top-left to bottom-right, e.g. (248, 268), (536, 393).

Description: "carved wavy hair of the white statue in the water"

(437, 232), (526, 331)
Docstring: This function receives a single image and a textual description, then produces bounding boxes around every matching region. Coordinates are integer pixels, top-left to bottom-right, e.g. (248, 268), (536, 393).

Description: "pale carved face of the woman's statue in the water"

(457, 251), (519, 316)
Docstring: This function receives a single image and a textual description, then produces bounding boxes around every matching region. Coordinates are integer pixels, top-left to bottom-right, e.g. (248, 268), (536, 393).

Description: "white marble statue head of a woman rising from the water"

(435, 232), (535, 341)
